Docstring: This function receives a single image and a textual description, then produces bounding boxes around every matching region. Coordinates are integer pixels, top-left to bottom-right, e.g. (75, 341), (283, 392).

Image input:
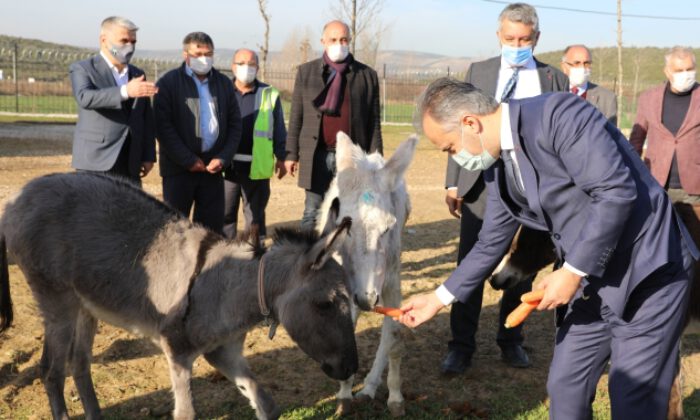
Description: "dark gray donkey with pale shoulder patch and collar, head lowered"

(0, 173), (358, 419)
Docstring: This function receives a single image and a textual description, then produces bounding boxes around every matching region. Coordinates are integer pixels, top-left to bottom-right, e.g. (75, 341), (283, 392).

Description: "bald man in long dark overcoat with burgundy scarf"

(285, 20), (382, 228)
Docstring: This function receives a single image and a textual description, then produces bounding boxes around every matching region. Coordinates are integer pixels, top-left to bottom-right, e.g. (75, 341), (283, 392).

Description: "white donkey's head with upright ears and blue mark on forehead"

(322, 132), (418, 310)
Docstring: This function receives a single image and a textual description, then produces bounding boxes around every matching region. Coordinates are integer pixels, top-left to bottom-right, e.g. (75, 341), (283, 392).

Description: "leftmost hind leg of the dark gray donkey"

(39, 313), (77, 420)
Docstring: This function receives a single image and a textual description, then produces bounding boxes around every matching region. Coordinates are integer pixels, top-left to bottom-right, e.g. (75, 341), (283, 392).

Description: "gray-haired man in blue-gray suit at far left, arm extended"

(70, 16), (158, 185)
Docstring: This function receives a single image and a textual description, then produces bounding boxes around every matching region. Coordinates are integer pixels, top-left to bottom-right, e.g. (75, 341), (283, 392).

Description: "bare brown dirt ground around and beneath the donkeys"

(0, 124), (700, 419)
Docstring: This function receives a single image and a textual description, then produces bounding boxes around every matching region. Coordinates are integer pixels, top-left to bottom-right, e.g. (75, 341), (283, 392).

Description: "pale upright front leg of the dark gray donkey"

(160, 337), (195, 420)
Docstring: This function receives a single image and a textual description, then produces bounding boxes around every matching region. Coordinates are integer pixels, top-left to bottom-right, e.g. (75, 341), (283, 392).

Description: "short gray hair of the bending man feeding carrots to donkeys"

(413, 77), (498, 133)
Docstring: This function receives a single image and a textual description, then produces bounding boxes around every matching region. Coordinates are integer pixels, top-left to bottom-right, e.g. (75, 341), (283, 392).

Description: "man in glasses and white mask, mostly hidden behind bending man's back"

(561, 45), (617, 125)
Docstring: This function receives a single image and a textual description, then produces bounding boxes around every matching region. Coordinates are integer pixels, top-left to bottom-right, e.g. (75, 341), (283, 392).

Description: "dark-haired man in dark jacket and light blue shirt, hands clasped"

(154, 32), (241, 234)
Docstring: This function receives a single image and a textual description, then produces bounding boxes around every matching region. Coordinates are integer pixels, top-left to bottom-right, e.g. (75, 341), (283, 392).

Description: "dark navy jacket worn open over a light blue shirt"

(153, 63), (241, 176)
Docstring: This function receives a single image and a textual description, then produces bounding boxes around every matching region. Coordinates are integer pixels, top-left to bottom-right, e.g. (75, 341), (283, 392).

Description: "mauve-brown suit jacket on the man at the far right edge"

(630, 84), (700, 194)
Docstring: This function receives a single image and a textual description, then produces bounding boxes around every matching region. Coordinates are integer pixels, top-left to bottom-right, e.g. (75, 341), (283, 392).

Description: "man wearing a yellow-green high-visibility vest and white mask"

(224, 48), (287, 240)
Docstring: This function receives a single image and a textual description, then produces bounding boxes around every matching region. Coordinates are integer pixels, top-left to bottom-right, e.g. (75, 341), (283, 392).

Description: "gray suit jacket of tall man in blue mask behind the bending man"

(445, 56), (569, 197)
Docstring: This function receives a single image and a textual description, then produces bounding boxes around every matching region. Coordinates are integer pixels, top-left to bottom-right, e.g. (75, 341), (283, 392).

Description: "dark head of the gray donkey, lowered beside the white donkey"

(266, 219), (358, 380)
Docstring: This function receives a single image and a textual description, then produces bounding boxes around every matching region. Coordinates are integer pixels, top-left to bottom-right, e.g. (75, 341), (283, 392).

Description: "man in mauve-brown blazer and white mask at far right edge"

(630, 47), (700, 204)
